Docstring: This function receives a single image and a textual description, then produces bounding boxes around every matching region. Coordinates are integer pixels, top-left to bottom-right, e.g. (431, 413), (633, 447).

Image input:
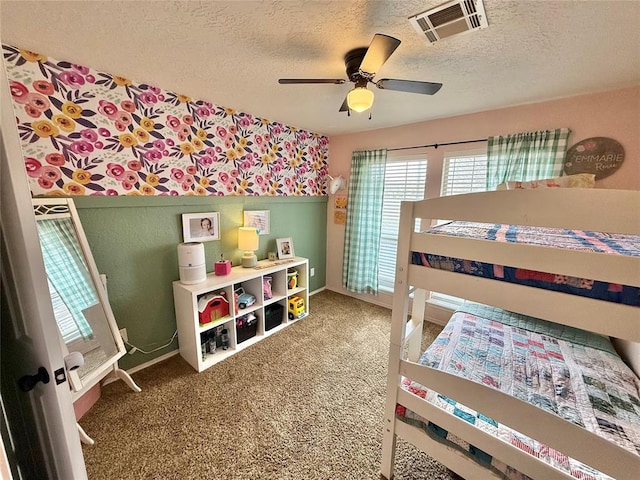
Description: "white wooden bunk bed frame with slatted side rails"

(381, 188), (640, 480)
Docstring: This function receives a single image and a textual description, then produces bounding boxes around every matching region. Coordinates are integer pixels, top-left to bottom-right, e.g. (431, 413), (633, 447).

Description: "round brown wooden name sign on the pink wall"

(564, 137), (624, 180)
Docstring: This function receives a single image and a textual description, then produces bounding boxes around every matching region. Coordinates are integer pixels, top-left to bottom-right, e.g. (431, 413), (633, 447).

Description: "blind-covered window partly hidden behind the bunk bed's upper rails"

(429, 150), (487, 309)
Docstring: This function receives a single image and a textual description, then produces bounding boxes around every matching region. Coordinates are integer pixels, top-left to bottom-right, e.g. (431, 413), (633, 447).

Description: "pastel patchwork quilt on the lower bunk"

(396, 303), (640, 480)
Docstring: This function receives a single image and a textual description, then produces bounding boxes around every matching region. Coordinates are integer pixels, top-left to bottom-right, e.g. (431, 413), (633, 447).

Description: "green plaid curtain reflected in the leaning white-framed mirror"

(38, 218), (98, 339)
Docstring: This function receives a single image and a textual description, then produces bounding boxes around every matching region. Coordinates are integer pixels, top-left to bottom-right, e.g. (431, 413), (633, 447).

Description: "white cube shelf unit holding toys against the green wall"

(173, 257), (309, 372)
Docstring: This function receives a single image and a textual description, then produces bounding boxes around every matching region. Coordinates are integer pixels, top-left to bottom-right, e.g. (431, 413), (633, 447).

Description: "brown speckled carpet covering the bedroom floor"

(80, 291), (458, 480)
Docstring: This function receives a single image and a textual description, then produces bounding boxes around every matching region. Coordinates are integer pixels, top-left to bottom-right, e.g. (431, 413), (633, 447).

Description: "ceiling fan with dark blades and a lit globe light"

(278, 33), (442, 114)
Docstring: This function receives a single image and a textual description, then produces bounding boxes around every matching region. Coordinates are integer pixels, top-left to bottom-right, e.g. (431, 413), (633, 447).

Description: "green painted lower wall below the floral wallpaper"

(74, 193), (327, 369)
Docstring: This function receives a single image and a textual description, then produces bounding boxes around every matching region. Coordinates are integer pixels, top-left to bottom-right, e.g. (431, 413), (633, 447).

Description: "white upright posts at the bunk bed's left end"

(380, 202), (425, 480)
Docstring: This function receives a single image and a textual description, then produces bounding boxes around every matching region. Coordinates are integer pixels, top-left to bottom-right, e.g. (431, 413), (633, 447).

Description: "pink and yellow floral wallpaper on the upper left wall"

(2, 44), (329, 196)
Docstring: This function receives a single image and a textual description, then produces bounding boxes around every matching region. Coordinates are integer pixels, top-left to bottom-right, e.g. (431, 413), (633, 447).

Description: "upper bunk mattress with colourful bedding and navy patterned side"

(411, 221), (640, 306)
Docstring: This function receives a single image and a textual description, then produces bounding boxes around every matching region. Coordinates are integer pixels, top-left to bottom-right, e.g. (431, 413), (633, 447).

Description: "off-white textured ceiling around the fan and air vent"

(0, 0), (640, 135)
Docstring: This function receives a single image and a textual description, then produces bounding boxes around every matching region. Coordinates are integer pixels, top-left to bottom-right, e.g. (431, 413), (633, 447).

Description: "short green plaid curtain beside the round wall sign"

(487, 128), (571, 191)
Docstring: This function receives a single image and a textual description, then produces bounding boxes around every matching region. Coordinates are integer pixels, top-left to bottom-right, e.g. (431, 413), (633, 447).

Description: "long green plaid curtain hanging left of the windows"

(342, 150), (387, 295)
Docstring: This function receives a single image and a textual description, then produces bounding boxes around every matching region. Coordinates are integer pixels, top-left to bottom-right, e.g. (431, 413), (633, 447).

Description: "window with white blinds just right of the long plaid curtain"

(378, 153), (427, 292)
